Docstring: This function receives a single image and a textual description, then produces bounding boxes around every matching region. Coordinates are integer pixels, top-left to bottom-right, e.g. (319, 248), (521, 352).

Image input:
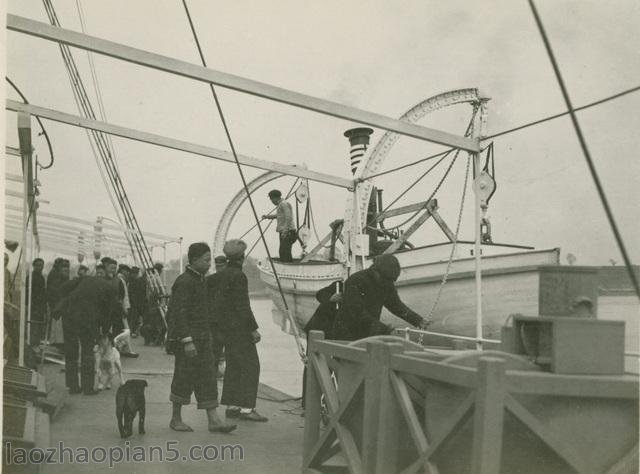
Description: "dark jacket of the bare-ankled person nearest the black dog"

(167, 266), (211, 342)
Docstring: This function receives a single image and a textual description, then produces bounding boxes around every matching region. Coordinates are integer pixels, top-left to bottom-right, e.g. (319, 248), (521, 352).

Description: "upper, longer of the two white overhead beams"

(7, 15), (480, 153)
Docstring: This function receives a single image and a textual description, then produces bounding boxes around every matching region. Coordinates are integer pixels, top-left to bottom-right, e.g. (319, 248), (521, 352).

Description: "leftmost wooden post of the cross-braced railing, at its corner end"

(302, 331), (324, 472)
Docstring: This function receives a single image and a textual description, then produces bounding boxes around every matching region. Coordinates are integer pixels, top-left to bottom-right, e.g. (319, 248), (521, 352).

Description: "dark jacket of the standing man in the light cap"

(210, 262), (258, 335)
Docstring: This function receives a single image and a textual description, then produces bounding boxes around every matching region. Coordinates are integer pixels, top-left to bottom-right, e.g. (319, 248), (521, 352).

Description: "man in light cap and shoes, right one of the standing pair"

(213, 239), (267, 421)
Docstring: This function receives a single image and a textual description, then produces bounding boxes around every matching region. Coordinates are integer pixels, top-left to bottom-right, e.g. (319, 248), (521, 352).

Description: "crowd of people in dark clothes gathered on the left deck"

(20, 257), (162, 395)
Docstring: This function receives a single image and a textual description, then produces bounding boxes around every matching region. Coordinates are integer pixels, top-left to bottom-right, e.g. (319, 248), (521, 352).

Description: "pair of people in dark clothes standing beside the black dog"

(167, 239), (267, 433)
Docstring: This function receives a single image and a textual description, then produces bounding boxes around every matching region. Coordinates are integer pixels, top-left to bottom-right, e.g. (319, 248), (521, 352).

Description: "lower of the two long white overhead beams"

(6, 100), (353, 189)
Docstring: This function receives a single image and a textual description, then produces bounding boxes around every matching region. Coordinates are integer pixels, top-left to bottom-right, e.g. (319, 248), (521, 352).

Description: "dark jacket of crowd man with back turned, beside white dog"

(61, 276), (116, 337)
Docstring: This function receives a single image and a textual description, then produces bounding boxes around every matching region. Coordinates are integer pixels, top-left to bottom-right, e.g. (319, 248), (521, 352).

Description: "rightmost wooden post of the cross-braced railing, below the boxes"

(471, 357), (505, 474)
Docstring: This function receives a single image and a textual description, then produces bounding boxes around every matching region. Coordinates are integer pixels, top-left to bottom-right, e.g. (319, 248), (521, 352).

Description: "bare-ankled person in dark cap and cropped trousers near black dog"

(168, 242), (236, 433)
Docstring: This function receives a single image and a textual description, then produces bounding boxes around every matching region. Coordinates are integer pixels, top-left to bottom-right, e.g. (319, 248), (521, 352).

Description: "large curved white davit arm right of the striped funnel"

(345, 88), (487, 235)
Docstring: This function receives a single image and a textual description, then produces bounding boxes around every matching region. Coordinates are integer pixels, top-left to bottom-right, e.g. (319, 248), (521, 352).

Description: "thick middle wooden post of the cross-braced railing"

(362, 341), (404, 474)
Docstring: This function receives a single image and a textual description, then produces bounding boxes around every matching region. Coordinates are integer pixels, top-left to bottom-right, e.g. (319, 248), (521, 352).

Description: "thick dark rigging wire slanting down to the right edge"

(528, 0), (640, 298)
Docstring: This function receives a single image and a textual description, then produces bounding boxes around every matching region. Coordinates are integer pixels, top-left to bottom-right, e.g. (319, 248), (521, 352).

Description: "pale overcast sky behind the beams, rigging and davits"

(1, 0), (640, 265)
